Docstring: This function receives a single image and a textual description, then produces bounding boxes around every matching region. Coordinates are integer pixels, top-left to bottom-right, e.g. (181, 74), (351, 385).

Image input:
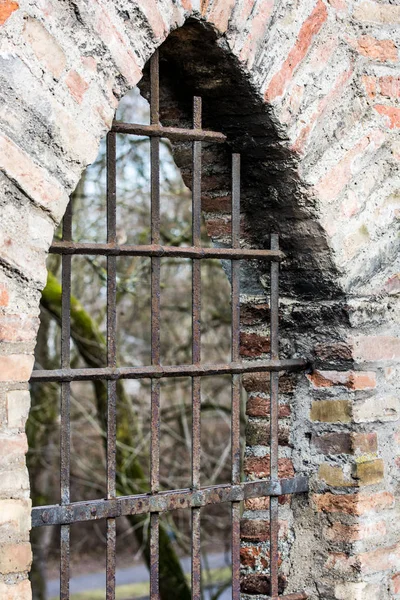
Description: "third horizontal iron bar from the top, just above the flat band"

(31, 358), (308, 382)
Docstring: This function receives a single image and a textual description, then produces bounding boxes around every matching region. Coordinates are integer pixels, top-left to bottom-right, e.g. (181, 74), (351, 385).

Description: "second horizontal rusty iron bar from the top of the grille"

(50, 241), (285, 260)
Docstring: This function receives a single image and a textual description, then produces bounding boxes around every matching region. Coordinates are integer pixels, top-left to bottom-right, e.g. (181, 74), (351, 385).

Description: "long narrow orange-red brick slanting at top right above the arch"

(265, 0), (328, 102)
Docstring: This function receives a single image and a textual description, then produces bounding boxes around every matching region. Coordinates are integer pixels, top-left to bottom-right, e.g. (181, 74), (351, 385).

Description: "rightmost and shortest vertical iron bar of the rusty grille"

(269, 233), (279, 599)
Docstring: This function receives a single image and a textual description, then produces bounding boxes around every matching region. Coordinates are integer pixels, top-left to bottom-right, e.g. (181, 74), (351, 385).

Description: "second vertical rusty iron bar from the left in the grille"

(106, 132), (117, 600)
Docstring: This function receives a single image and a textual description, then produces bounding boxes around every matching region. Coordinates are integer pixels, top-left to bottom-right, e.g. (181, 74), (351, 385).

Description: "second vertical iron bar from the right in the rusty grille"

(231, 154), (240, 600)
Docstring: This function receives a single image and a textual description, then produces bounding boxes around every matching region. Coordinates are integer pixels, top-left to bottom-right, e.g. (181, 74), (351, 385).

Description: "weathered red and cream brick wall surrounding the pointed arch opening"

(0, 0), (400, 600)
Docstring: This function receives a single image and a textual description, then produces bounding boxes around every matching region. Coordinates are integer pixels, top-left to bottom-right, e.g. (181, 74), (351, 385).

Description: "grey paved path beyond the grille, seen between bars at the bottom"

(47, 553), (232, 600)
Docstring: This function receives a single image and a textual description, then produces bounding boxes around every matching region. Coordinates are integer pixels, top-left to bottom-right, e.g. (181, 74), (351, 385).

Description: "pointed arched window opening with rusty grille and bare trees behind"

(29, 38), (307, 600)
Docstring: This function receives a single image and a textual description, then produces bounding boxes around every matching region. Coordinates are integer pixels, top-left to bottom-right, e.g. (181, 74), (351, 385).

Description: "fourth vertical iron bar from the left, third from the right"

(192, 97), (201, 600)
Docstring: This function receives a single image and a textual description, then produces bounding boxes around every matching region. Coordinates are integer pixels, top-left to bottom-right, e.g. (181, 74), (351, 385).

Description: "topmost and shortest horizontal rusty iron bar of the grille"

(111, 121), (226, 144)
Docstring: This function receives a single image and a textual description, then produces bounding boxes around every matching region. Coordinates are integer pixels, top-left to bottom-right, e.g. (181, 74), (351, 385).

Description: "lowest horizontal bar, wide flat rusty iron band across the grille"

(32, 476), (308, 527)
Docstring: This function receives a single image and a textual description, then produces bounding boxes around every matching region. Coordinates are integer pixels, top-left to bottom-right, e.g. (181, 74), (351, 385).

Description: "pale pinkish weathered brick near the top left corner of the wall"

(23, 18), (67, 79)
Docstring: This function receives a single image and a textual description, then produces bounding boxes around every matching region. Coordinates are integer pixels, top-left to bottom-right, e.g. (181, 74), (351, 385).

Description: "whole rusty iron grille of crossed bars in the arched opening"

(31, 52), (308, 600)
